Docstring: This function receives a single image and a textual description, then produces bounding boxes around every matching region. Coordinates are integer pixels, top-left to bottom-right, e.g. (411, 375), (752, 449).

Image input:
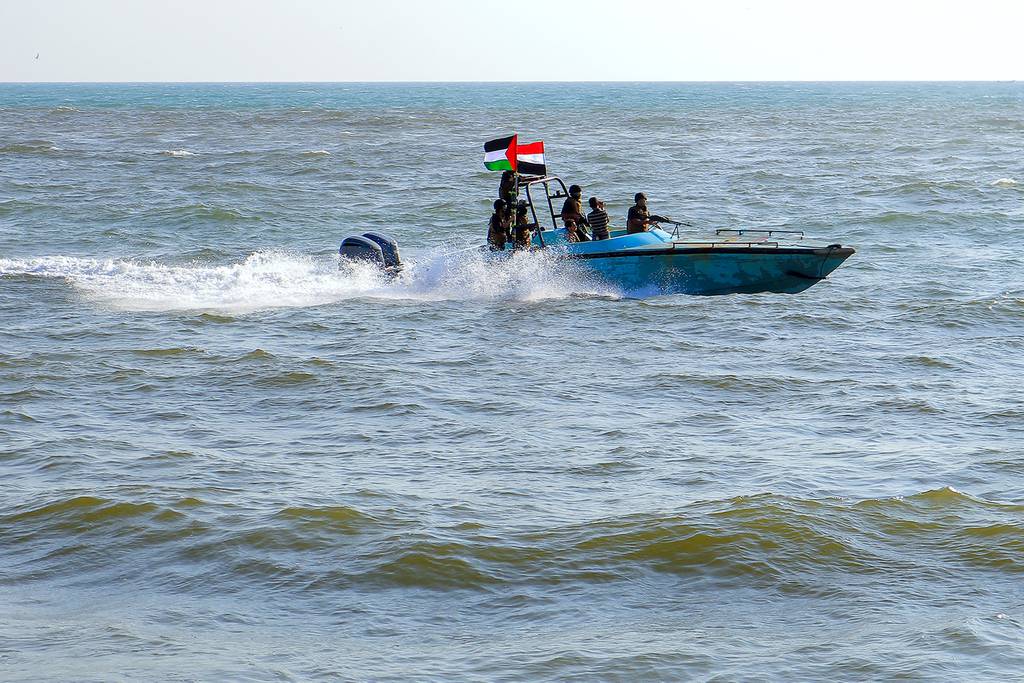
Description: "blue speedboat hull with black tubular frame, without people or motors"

(507, 176), (854, 295)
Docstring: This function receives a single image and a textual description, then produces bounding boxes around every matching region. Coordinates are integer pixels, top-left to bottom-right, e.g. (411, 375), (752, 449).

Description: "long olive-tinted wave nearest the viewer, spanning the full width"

(0, 487), (1024, 590)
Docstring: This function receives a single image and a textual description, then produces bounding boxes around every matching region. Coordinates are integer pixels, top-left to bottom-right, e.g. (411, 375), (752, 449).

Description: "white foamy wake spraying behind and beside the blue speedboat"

(0, 248), (620, 313)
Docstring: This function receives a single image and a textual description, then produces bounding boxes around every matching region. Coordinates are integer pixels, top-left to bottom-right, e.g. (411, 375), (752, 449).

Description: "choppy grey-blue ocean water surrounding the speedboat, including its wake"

(0, 83), (1024, 681)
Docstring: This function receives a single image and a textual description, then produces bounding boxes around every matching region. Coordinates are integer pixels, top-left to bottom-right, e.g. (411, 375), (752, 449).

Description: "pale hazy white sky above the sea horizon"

(0, 0), (1024, 81)
